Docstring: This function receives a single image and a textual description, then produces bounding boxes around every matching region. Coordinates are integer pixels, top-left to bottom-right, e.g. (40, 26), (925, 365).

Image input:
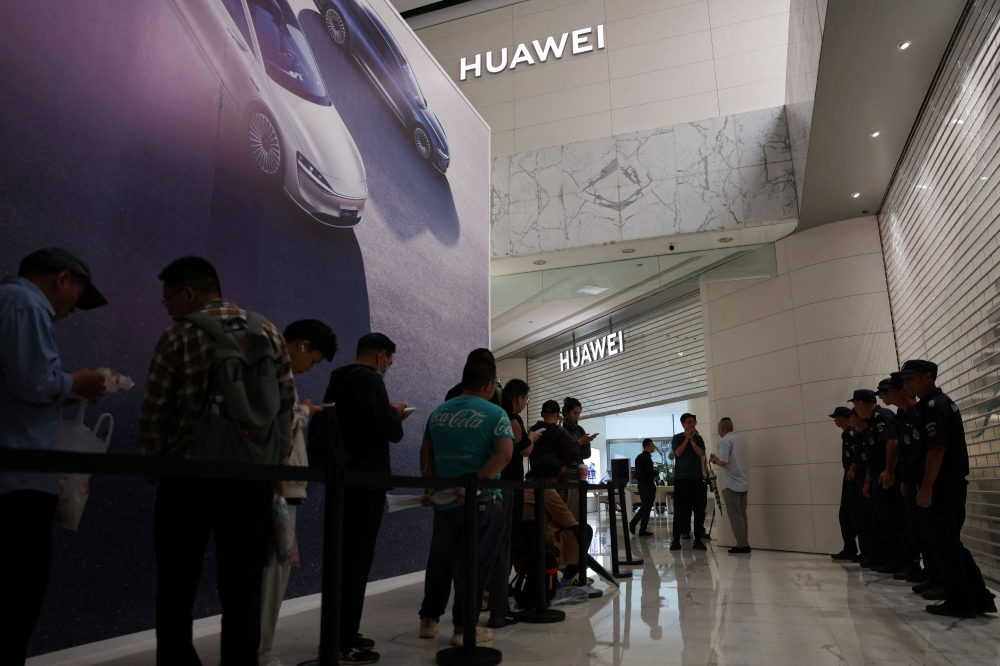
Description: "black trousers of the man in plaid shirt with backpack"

(153, 479), (274, 666)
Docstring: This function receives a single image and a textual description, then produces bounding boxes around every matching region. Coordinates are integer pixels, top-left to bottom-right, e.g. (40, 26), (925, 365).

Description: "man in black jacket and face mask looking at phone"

(323, 333), (408, 664)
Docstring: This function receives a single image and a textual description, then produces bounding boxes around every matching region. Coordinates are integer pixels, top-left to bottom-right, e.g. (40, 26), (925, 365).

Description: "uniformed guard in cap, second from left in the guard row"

(851, 389), (916, 574)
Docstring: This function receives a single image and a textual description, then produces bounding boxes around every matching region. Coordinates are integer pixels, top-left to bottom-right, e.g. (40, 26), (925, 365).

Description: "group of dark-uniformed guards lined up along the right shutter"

(830, 359), (997, 618)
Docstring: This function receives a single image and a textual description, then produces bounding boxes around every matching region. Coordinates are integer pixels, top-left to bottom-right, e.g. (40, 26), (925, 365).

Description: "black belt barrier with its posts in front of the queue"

(0, 447), (617, 666)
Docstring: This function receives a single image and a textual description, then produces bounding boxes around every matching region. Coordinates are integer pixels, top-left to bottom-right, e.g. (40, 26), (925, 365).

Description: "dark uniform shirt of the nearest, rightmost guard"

(913, 389), (969, 485)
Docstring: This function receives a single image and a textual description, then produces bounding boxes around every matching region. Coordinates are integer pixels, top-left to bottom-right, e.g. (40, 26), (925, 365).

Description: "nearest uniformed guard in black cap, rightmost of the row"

(899, 360), (997, 618)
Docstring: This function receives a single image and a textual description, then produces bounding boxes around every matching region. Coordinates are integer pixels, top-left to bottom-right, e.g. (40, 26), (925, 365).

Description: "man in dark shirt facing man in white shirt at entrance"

(670, 414), (706, 550)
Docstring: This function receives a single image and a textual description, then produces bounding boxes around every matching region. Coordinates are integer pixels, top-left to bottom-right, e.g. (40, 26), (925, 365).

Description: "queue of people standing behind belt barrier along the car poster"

(0, 248), (594, 666)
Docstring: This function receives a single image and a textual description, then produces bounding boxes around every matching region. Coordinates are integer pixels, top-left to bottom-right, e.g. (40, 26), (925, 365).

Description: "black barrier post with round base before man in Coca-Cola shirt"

(436, 474), (503, 666)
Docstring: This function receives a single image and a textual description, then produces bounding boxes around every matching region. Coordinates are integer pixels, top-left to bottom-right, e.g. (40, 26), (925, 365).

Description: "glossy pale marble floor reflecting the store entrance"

(95, 519), (1000, 666)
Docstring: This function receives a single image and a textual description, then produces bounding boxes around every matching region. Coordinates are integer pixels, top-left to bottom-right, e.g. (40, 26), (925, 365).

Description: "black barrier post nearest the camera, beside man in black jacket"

(319, 455), (345, 666)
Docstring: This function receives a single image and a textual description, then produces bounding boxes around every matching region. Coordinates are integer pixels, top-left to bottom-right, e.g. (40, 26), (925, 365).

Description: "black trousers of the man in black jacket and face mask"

(340, 487), (385, 653)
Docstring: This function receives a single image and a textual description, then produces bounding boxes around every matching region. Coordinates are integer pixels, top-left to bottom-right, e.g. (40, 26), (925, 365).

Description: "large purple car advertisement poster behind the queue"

(0, 0), (490, 654)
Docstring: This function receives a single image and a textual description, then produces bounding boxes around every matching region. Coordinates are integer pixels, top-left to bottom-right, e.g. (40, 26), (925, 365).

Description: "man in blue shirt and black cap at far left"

(0, 248), (107, 664)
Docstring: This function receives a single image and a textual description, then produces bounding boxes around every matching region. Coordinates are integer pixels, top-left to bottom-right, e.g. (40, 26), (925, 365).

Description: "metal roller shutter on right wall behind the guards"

(879, 0), (1000, 581)
